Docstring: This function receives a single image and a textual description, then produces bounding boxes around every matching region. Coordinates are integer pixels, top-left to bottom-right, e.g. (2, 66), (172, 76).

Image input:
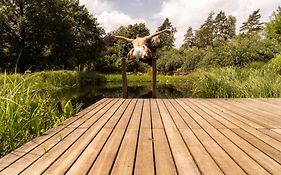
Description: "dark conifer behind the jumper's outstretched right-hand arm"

(154, 18), (177, 49)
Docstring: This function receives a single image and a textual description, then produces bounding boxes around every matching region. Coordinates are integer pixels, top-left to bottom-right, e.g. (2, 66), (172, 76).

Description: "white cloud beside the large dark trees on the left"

(80, 0), (146, 32)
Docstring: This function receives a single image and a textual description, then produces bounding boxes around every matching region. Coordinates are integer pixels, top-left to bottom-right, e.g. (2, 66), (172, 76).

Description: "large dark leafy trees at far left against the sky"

(0, 0), (104, 72)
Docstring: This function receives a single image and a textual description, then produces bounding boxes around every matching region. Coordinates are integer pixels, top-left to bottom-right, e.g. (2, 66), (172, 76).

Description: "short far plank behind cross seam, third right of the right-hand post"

(167, 99), (201, 129)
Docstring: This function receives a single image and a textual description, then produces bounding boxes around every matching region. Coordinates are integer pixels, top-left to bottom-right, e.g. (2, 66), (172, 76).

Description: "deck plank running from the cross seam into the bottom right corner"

(220, 129), (281, 174)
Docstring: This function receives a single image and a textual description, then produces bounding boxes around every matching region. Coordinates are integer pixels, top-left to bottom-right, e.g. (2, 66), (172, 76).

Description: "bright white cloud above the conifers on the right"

(154, 0), (280, 47)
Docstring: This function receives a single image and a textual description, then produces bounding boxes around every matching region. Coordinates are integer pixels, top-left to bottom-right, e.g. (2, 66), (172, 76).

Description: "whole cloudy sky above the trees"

(80, 0), (281, 47)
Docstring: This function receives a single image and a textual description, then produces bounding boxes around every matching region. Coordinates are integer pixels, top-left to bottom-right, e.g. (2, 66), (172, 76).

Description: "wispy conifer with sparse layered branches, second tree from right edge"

(240, 9), (264, 33)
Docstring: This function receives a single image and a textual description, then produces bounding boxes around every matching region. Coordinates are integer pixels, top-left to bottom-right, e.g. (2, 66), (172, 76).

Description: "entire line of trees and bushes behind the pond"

(0, 0), (281, 73)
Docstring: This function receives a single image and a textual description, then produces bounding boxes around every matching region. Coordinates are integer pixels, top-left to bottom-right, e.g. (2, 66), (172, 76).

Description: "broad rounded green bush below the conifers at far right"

(200, 33), (281, 67)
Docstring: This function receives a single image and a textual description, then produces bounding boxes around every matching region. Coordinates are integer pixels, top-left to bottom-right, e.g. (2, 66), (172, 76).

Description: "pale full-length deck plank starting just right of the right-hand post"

(157, 99), (200, 174)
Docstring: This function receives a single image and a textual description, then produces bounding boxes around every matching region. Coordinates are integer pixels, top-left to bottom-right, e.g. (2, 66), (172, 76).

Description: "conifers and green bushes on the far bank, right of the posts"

(158, 7), (281, 73)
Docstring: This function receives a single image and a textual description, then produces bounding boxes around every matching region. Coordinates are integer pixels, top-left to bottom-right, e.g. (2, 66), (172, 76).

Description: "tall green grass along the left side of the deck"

(0, 74), (80, 157)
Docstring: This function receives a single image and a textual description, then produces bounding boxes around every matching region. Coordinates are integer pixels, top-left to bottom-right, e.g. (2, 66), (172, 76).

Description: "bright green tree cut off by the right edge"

(265, 6), (281, 43)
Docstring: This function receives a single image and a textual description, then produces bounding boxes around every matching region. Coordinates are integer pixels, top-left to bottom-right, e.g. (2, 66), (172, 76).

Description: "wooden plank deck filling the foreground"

(0, 99), (281, 175)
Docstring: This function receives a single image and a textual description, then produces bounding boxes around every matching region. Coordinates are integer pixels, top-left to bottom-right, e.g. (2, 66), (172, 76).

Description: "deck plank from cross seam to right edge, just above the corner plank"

(233, 129), (281, 164)
